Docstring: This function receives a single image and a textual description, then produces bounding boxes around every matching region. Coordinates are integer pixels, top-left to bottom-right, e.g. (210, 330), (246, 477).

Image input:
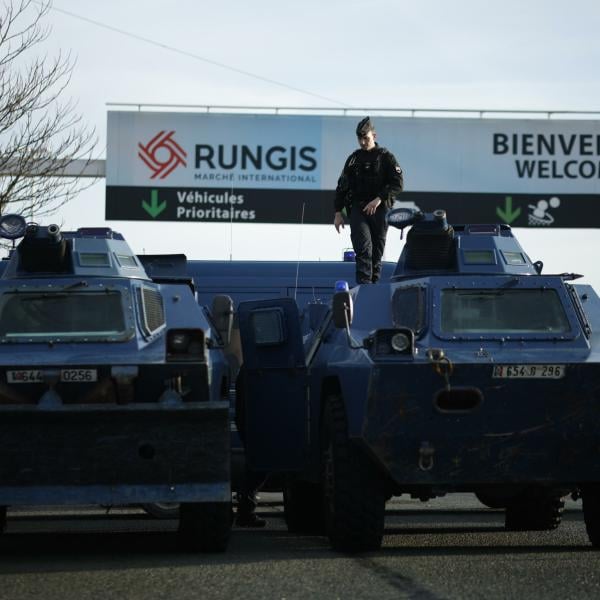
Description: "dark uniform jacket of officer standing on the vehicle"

(335, 145), (404, 212)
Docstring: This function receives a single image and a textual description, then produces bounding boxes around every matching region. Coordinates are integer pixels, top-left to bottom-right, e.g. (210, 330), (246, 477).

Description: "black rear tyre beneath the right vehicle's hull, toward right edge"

(505, 492), (565, 531)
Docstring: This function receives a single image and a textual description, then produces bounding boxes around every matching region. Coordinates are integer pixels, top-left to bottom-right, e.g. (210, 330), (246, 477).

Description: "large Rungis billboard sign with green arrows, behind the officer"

(106, 111), (600, 227)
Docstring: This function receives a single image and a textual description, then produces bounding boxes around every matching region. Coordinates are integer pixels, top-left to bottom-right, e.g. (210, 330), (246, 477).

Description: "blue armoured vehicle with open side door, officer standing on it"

(238, 209), (600, 551)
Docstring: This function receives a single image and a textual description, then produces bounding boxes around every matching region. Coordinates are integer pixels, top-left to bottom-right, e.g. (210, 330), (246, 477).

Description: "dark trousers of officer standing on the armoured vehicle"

(350, 204), (387, 283)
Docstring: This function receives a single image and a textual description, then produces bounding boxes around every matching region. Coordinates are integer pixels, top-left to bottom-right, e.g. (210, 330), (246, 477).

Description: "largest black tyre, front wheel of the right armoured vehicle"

(321, 397), (385, 552)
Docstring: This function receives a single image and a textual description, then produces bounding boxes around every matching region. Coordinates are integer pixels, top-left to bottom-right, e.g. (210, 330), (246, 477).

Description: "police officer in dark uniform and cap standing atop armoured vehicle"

(333, 117), (404, 283)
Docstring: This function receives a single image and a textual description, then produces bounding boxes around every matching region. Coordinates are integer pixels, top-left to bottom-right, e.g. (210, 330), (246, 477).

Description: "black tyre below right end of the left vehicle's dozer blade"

(179, 502), (231, 552)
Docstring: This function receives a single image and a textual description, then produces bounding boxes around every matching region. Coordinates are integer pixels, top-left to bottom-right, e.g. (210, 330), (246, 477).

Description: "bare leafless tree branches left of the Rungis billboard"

(0, 0), (97, 218)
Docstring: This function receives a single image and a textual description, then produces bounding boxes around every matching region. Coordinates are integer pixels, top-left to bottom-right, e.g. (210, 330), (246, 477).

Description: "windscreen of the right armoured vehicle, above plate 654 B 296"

(441, 289), (571, 334)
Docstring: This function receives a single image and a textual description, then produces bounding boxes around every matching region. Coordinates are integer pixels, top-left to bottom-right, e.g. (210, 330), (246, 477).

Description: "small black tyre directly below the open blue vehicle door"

(283, 481), (326, 535)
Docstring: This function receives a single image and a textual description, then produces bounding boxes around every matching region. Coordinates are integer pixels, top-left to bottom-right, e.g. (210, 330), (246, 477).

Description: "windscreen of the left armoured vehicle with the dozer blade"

(0, 291), (126, 339)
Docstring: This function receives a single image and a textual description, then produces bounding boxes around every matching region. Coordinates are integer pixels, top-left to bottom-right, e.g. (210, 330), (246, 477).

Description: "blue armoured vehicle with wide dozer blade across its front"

(0, 215), (232, 551)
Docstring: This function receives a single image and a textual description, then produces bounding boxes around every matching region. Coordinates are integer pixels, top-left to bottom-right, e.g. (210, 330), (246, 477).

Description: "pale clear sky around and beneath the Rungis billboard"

(25, 0), (600, 289)
